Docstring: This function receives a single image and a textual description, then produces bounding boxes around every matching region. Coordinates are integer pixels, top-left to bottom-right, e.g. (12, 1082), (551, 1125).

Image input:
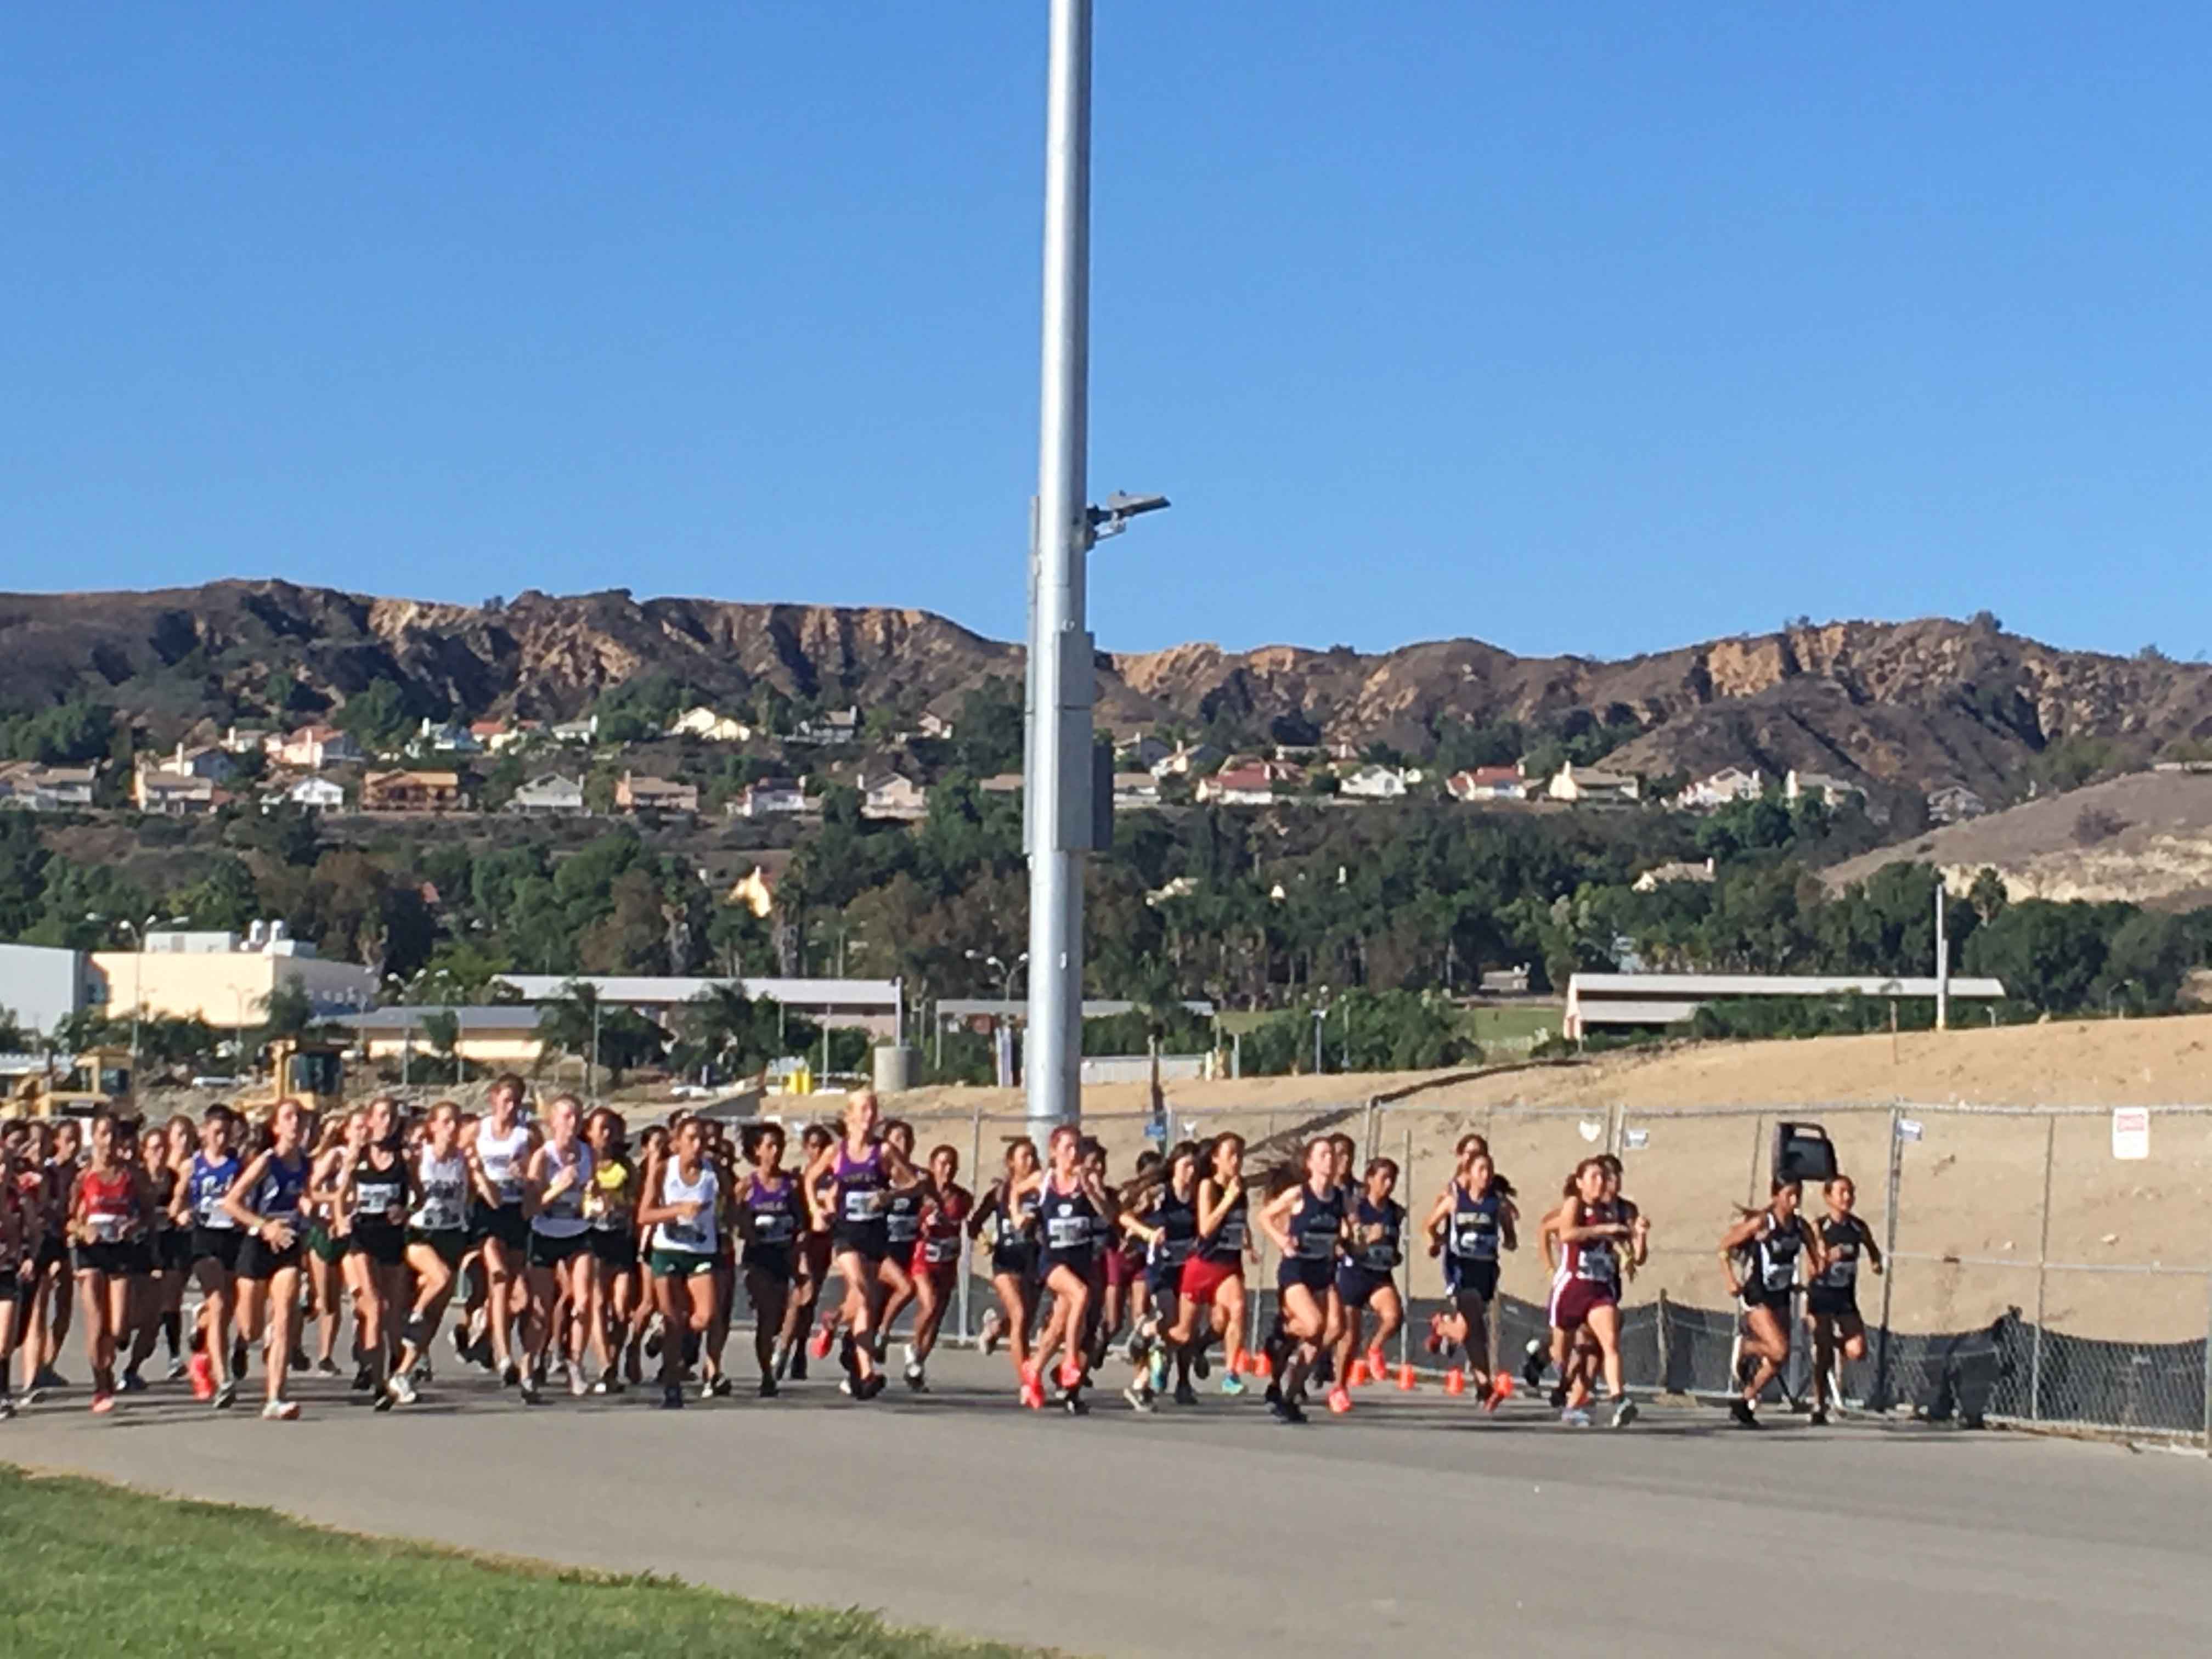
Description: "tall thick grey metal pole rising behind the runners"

(1022, 0), (1097, 1132)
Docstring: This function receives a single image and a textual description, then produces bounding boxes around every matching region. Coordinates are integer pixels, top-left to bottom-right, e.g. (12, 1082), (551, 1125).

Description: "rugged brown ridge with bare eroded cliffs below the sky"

(0, 582), (2212, 801)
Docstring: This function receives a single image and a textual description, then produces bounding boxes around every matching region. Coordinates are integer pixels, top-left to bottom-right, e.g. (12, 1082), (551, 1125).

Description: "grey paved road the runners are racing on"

(0, 1356), (2212, 1659)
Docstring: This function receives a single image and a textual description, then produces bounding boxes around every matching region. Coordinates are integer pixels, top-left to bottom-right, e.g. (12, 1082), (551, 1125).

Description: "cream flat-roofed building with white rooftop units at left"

(88, 924), (376, 1026)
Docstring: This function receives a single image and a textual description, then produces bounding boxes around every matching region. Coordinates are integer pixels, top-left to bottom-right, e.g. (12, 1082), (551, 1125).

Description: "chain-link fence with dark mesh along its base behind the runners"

(884, 1097), (2212, 1451)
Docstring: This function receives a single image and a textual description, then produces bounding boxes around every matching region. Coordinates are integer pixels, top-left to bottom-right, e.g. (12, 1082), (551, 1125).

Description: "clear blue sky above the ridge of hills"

(0, 0), (2212, 657)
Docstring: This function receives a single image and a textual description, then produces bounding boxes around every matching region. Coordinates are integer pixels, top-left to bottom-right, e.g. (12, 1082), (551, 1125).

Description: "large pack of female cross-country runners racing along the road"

(0, 1075), (1880, 1427)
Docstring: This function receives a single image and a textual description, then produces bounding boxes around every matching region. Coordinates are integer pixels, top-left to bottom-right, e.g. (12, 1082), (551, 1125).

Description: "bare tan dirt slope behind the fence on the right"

(896, 1015), (2212, 1340)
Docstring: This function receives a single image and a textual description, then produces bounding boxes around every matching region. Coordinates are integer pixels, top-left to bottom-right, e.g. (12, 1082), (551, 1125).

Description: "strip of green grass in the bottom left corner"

(0, 1466), (1044, 1659)
